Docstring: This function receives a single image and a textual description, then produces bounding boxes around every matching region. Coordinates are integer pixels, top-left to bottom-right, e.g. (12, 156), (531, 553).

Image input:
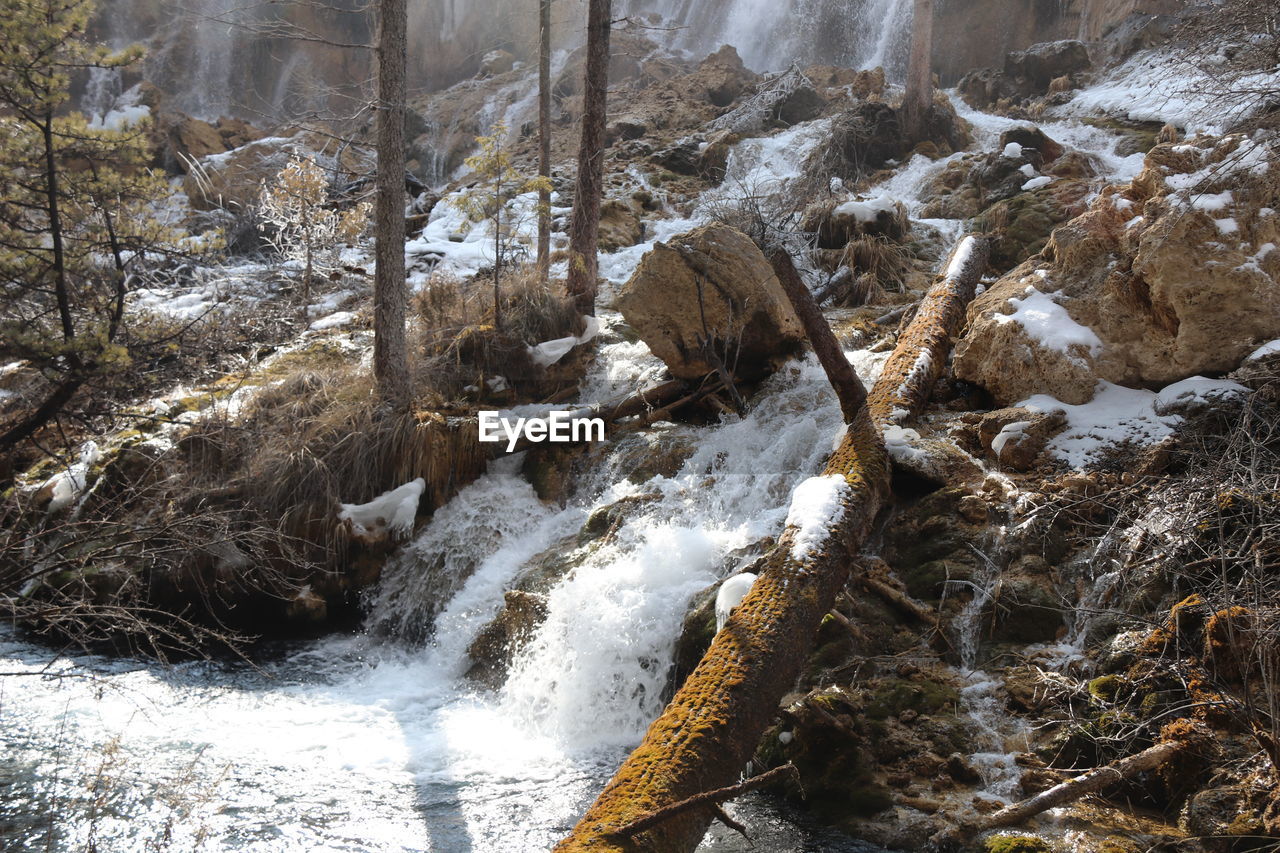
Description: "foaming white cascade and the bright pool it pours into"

(0, 322), (884, 853)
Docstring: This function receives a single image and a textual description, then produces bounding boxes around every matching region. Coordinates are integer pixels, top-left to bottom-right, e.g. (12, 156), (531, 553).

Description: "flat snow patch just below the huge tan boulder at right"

(1018, 380), (1183, 469)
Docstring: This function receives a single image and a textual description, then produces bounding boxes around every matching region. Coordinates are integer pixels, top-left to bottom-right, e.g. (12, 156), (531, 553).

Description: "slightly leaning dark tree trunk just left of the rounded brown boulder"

(567, 0), (613, 314)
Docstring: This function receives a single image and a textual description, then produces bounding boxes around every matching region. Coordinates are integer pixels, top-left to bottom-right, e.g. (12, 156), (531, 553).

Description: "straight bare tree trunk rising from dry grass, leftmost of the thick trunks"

(374, 0), (410, 407)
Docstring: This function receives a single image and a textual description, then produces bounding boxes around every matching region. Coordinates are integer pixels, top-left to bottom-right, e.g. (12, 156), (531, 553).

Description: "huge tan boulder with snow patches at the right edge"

(955, 136), (1280, 405)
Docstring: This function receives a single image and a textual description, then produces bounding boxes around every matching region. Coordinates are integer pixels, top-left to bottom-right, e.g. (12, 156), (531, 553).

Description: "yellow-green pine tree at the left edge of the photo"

(0, 0), (188, 450)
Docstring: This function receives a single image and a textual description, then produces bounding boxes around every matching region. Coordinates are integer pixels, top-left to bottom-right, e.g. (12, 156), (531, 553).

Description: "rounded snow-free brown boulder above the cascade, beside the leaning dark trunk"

(617, 224), (804, 379)
